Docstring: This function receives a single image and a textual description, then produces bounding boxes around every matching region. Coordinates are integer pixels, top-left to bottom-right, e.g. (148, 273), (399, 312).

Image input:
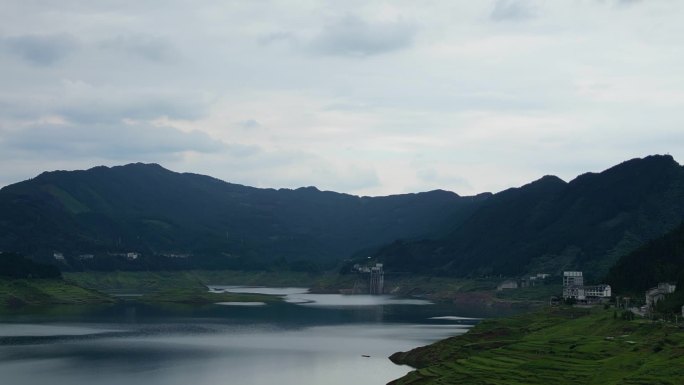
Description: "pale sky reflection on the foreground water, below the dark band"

(0, 324), (462, 385)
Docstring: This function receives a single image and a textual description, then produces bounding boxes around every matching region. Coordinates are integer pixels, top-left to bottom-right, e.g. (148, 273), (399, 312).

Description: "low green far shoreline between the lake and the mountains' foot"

(0, 270), (556, 311)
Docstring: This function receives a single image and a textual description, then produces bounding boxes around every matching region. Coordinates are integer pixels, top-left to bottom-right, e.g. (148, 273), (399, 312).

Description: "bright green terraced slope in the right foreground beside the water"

(391, 307), (684, 385)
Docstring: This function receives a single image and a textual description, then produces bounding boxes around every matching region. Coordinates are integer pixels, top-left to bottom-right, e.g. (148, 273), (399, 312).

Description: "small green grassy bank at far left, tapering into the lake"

(0, 279), (113, 308)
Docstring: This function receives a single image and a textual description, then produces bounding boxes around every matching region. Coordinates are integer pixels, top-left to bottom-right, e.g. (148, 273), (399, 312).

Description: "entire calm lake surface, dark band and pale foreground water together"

(0, 286), (508, 385)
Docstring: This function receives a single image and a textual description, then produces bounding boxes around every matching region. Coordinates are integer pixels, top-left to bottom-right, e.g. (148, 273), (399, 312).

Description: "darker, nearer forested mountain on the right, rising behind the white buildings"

(371, 155), (684, 278)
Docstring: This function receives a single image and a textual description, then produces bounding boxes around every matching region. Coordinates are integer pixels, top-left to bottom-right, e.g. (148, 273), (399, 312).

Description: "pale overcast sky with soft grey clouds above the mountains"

(0, 0), (684, 195)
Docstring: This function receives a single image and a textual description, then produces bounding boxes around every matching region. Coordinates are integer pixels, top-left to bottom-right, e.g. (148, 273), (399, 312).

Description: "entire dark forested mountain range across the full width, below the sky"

(0, 156), (684, 277)
